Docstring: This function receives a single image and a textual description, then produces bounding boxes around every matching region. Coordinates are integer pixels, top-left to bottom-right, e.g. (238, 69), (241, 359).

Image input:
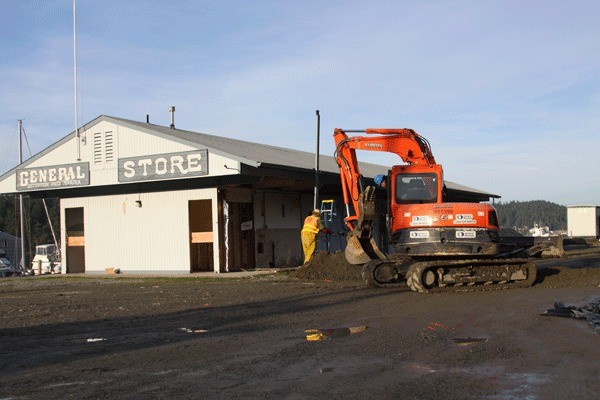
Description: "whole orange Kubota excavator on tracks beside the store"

(333, 128), (536, 293)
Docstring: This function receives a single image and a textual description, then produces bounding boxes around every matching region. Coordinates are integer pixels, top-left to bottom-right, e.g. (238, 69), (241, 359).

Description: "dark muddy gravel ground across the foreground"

(0, 248), (600, 399)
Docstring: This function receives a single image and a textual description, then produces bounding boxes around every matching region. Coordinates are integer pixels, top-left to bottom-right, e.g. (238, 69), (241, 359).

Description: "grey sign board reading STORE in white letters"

(119, 149), (208, 182)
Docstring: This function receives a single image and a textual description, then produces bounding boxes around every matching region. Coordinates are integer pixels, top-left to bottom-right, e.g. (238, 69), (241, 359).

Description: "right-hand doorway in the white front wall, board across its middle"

(188, 200), (214, 272)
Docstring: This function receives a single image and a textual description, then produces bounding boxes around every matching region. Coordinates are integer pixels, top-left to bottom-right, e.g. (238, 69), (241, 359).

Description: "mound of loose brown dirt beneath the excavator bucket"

(293, 251), (362, 281)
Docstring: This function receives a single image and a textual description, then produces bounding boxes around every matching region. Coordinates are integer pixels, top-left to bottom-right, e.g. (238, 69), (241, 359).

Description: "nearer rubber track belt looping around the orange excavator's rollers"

(406, 259), (537, 293)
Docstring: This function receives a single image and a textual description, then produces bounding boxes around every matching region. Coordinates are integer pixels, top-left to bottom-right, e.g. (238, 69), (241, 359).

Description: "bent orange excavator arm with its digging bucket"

(333, 128), (435, 264)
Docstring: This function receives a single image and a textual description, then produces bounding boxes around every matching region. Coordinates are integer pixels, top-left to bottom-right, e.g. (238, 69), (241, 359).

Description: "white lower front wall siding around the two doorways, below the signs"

(60, 189), (219, 273)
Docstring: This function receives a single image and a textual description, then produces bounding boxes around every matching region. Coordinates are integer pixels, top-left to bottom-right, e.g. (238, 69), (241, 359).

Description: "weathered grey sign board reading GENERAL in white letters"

(17, 163), (90, 191)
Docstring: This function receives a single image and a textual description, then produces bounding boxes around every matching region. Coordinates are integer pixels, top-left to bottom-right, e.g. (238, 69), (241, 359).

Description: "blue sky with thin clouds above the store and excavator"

(0, 0), (600, 205)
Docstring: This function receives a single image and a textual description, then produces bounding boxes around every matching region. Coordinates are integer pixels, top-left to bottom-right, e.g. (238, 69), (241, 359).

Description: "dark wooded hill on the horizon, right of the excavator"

(494, 200), (567, 233)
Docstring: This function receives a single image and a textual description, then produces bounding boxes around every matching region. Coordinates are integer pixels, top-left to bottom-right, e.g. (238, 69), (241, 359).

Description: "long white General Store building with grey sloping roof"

(0, 116), (499, 273)
